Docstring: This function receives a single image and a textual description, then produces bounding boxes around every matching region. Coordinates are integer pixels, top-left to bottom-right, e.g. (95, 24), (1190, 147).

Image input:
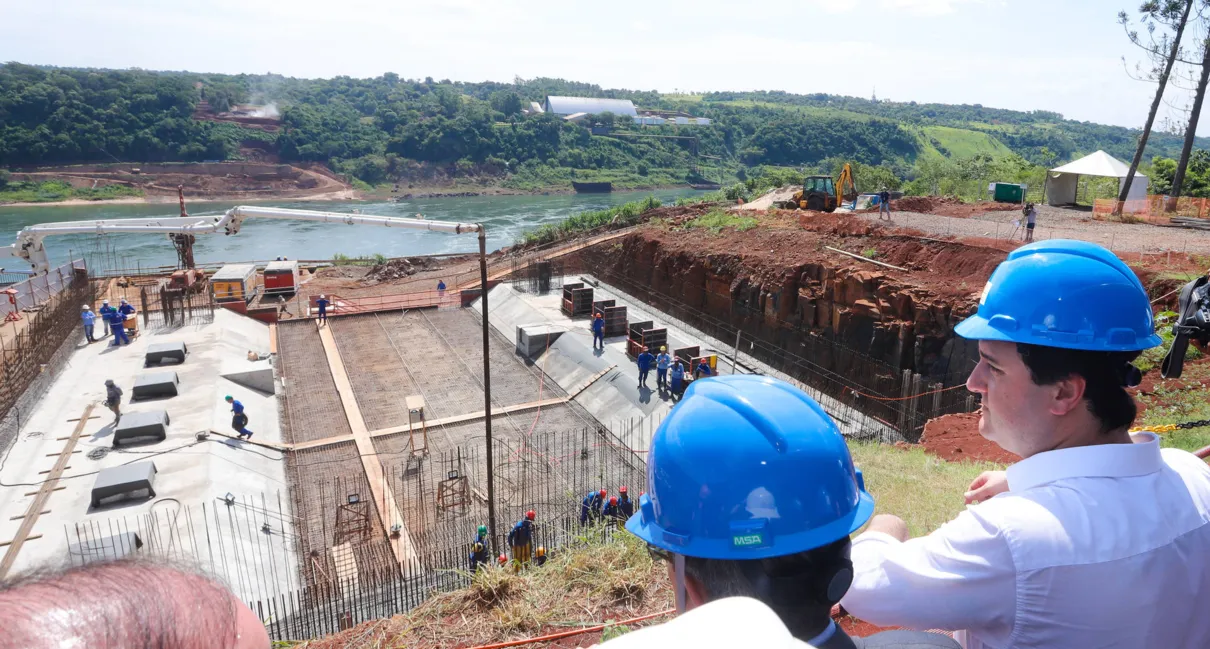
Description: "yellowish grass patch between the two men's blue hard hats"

(848, 442), (1003, 536)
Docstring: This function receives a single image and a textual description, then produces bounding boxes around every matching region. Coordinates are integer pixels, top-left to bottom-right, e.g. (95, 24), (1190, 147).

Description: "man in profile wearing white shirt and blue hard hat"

(841, 240), (1210, 649)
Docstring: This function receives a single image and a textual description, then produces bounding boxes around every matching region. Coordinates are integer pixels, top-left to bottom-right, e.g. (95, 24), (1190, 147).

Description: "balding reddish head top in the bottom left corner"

(0, 559), (269, 649)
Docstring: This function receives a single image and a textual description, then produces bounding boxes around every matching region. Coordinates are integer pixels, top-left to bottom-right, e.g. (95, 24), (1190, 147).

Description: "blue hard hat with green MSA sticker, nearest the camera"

(626, 374), (874, 559)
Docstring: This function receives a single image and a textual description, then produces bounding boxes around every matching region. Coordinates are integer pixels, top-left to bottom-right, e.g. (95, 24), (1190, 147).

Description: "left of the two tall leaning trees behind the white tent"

(1113, 0), (1194, 213)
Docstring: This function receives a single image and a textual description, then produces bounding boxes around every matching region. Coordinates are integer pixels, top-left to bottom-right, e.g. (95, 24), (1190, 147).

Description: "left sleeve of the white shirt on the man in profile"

(841, 510), (1016, 637)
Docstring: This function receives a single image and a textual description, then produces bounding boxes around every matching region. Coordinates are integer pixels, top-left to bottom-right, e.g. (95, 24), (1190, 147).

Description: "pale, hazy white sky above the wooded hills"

(0, 0), (1210, 136)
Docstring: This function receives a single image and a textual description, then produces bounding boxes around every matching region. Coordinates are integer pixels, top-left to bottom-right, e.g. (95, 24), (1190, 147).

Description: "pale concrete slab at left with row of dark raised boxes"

(0, 309), (301, 601)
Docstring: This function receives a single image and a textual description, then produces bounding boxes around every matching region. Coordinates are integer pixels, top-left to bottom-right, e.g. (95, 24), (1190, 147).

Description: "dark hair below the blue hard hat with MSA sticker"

(685, 536), (852, 638)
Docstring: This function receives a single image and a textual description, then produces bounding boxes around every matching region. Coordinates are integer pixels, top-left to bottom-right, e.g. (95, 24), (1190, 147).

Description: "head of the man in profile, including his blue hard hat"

(955, 240), (1160, 458)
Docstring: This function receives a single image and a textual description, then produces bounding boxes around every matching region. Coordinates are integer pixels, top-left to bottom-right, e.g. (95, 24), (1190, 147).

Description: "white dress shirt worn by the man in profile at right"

(841, 433), (1210, 649)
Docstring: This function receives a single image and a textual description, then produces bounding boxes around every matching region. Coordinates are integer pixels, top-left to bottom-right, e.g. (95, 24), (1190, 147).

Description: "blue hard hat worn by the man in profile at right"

(953, 239), (1163, 351)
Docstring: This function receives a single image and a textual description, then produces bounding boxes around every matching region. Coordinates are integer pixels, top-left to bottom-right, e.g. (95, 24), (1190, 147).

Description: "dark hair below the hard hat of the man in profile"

(1016, 343), (1142, 432)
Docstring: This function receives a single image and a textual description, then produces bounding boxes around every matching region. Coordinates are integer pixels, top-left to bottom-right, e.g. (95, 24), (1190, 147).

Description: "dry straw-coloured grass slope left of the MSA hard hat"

(296, 533), (673, 649)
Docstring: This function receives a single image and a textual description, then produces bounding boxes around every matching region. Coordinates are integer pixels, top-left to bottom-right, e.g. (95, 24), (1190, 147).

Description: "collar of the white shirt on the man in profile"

(1008, 432), (1164, 492)
